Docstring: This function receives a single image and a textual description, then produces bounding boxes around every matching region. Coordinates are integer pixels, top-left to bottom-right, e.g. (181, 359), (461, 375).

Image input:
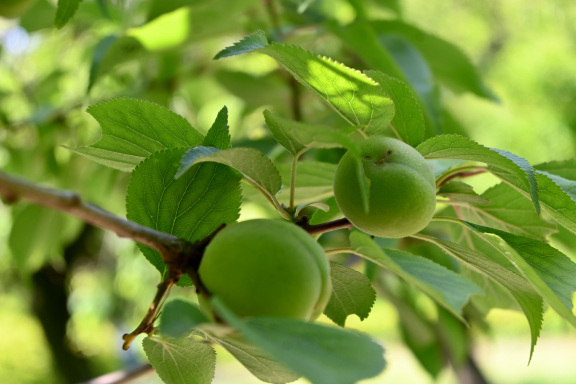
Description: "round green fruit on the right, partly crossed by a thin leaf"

(334, 137), (436, 238)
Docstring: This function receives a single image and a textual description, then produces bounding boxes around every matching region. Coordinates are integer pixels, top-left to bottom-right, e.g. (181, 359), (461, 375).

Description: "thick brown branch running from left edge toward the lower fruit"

(0, 172), (191, 264)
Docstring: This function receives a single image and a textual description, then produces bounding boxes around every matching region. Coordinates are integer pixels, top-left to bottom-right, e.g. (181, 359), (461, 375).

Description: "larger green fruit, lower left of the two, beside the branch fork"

(198, 219), (331, 320)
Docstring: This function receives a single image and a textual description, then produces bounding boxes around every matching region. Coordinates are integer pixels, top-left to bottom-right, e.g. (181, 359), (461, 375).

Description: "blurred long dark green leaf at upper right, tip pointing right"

(371, 20), (496, 100)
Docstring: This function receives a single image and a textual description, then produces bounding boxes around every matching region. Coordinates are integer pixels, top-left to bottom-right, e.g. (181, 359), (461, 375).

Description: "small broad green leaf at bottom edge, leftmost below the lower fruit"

(142, 337), (216, 384)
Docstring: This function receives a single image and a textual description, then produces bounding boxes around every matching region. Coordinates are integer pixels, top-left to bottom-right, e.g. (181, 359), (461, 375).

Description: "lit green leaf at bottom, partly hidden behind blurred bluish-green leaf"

(215, 336), (300, 384)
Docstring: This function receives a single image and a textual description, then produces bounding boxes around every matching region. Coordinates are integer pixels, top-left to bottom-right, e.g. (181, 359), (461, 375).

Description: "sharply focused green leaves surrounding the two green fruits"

(66, 27), (576, 383)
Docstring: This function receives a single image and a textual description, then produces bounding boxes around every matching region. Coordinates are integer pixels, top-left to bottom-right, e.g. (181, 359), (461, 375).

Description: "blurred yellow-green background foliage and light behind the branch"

(0, 0), (576, 384)
